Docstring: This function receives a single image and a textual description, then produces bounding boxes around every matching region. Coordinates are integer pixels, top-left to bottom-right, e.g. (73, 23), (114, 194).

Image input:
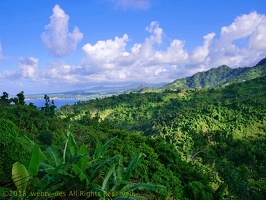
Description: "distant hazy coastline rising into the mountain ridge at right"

(26, 58), (266, 100)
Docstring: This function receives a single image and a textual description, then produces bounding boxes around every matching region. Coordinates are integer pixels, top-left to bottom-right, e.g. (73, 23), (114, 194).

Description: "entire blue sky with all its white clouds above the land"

(0, 0), (266, 94)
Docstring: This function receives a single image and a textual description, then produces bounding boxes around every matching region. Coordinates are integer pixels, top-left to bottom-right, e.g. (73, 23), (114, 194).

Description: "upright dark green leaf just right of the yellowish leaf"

(28, 145), (40, 176)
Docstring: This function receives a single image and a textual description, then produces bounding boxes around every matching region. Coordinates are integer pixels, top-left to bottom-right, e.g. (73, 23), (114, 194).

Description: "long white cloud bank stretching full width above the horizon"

(0, 11), (266, 94)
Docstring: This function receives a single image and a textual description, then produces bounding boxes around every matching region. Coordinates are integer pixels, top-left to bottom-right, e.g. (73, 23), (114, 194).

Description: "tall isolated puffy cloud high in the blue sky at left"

(41, 5), (83, 56)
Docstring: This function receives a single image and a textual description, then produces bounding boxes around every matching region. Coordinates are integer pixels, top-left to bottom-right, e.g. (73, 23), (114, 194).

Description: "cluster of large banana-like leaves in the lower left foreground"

(1, 129), (165, 199)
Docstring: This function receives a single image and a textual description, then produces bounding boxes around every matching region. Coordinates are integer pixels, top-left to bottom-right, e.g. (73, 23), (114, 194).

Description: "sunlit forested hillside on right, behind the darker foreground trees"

(57, 76), (266, 200)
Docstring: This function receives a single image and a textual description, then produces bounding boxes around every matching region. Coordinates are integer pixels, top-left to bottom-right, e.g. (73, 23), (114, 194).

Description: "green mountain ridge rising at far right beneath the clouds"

(160, 58), (266, 90)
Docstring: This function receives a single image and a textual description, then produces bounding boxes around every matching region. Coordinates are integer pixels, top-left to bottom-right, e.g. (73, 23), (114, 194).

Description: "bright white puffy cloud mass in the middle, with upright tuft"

(44, 22), (168, 84)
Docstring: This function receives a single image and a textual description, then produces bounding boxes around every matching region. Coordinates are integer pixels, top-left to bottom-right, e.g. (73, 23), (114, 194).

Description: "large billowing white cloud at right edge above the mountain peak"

(205, 12), (266, 67)
